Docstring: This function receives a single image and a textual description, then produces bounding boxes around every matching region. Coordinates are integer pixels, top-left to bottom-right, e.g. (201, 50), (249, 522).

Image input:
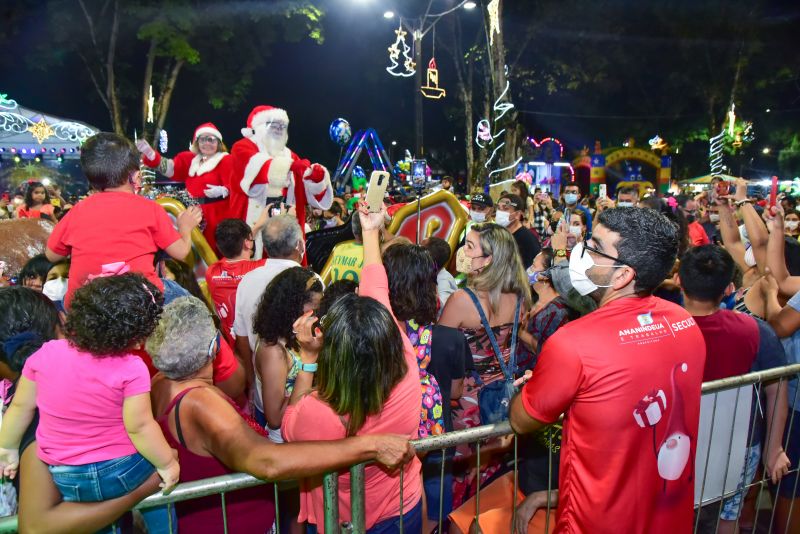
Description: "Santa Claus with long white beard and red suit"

(229, 106), (333, 257)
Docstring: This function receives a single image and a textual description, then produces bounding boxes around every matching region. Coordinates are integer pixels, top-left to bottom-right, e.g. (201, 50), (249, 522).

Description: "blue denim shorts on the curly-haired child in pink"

(49, 453), (155, 502)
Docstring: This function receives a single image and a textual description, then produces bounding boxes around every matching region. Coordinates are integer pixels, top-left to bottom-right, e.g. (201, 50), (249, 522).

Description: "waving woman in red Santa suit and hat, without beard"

(136, 122), (233, 255)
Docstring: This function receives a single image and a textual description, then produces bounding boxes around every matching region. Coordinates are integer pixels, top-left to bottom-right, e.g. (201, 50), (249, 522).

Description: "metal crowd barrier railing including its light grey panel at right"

(0, 364), (800, 534)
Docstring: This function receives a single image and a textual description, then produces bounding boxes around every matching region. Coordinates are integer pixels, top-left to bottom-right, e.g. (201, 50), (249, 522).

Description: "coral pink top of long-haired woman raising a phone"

(281, 264), (422, 533)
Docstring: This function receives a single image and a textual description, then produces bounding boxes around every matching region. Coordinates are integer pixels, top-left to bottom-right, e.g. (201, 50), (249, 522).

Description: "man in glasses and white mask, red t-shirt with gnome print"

(510, 208), (705, 534)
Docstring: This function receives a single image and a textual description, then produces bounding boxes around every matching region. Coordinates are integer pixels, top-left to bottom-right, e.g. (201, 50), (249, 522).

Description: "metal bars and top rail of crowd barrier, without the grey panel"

(0, 364), (800, 534)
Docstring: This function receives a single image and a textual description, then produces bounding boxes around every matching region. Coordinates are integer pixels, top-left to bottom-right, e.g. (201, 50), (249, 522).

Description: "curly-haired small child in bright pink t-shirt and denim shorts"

(0, 273), (180, 512)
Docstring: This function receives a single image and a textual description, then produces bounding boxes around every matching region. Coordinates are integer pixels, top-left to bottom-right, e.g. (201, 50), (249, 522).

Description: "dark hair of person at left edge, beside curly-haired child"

(0, 286), (59, 373)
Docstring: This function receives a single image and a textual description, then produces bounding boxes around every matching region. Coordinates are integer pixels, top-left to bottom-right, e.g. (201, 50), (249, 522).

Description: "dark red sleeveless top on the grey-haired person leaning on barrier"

(157, 386), (275, 534)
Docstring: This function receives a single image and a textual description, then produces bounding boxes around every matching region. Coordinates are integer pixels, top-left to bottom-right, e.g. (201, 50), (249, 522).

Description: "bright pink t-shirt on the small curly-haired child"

(22, 339), (150, 465)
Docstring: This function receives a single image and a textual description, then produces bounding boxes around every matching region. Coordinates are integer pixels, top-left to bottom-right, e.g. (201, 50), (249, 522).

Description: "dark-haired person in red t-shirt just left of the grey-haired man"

(206, 219), (267, 346)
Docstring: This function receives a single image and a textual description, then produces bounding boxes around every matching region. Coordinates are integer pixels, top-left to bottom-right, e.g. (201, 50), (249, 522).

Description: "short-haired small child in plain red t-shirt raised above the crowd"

(45, 132), (202, 306)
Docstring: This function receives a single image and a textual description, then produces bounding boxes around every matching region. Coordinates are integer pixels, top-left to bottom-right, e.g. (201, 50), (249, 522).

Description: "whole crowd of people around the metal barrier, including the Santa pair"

(0, 126), (800, 534)
